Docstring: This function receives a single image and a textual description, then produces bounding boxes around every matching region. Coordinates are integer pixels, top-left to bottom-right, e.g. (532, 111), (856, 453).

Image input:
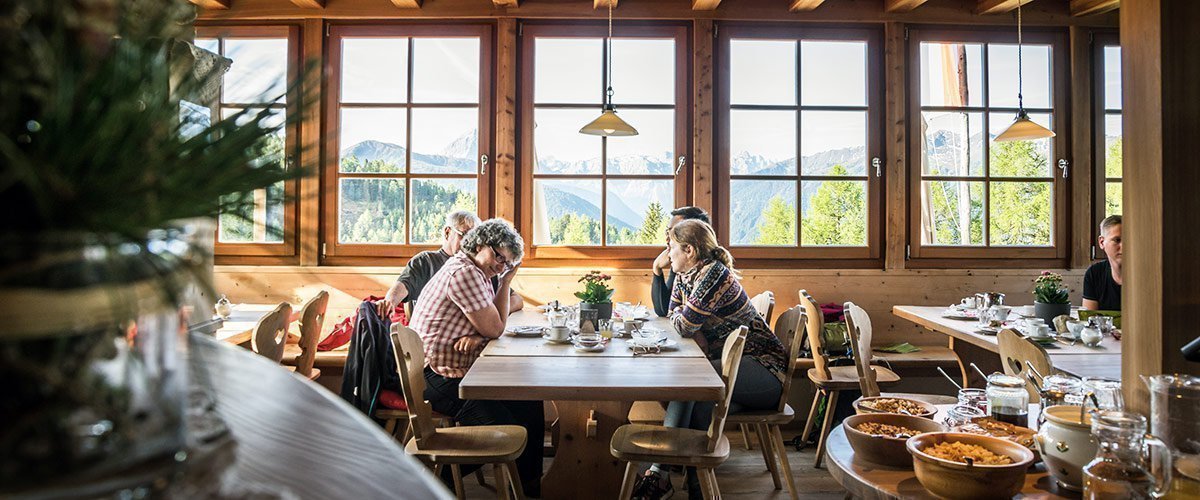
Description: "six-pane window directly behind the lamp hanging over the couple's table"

(521, 24), (690, 258)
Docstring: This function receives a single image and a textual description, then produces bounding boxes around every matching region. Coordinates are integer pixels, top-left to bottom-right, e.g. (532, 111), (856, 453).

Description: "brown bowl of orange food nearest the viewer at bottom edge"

(905, 433), (1033, 500)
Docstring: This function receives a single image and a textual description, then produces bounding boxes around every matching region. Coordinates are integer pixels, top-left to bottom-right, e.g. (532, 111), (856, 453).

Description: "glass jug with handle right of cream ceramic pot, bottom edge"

(1084, 410), (1172, 500)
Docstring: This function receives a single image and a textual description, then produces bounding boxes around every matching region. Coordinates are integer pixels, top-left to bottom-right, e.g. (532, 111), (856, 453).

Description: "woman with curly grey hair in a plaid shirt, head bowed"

(410, 218), (545, 498)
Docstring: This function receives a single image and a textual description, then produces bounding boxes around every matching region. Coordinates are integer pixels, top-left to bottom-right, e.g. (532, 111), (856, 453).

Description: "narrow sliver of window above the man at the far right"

(1093, 34), (1123, 220)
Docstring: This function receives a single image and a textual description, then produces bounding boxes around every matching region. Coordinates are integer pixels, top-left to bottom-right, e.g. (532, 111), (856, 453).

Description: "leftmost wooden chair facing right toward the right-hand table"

(799, 290), (900, 468)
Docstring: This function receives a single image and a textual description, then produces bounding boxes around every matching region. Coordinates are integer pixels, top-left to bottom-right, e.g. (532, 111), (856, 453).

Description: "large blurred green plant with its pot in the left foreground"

(0, 0), (302, 491)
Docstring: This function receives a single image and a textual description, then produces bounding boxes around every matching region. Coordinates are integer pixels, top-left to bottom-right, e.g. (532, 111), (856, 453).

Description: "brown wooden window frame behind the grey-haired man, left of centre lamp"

(320, 22), (496, 265)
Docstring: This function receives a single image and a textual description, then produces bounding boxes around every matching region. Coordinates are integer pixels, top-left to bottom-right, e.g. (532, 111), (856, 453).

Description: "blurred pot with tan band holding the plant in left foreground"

(0, 227), (202, 498)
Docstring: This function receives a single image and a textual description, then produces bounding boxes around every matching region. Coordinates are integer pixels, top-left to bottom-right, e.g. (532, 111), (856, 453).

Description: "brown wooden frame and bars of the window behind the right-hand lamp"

(905, 26), (1072, 264)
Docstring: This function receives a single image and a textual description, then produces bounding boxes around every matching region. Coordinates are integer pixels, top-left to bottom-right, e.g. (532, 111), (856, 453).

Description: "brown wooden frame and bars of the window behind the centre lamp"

(517, 20), (695, 263)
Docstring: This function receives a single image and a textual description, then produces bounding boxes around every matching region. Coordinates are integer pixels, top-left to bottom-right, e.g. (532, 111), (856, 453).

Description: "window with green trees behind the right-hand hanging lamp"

(910, 30), (1069, 259)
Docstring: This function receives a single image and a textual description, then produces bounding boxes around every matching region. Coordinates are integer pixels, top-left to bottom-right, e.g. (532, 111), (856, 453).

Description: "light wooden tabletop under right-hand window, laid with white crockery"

(892, 306), (1121, 380)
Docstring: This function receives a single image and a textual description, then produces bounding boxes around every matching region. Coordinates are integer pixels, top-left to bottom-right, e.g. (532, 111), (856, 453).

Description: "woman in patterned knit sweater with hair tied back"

(634, 219), (787, 499)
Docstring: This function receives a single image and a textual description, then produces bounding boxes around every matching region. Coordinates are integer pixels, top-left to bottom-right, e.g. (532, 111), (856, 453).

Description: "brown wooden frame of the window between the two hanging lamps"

(713, 23), (887, 262)
